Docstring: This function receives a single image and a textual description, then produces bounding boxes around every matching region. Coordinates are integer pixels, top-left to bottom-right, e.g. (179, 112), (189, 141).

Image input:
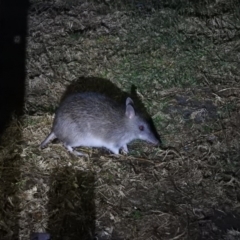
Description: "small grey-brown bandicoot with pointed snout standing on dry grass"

(41, 93), (159, 155)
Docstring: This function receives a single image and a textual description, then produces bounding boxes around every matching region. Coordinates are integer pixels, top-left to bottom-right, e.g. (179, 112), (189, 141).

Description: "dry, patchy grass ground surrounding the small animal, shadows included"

(0, 1), (240, 240)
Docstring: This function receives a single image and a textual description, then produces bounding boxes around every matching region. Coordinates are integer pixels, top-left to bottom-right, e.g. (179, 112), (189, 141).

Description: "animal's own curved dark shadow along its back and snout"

(61, 77), (161, 143)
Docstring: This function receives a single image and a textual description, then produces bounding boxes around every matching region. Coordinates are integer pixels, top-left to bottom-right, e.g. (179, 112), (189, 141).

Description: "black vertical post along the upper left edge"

(0, 0), (28, 135)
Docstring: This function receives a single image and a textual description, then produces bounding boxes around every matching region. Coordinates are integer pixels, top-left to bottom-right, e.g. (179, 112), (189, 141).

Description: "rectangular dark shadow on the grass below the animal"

(48, 167), (96, 240)
